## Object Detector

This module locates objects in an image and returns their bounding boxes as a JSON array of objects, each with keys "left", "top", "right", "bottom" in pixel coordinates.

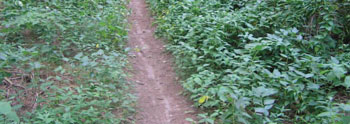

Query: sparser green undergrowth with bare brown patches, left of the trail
[{"left": 0, "top": 0, "right": 134, "bottom": 124}]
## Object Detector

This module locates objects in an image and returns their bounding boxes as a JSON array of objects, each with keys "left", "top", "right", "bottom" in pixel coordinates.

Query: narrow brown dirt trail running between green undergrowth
[{"left": 128, "top": 0, "right": 195, "bottom": 124}]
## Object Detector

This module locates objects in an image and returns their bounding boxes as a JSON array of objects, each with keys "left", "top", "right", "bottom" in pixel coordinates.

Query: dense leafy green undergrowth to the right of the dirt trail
[{"left": 148, "top": 0, "right": 350, "bottom": 124}]
